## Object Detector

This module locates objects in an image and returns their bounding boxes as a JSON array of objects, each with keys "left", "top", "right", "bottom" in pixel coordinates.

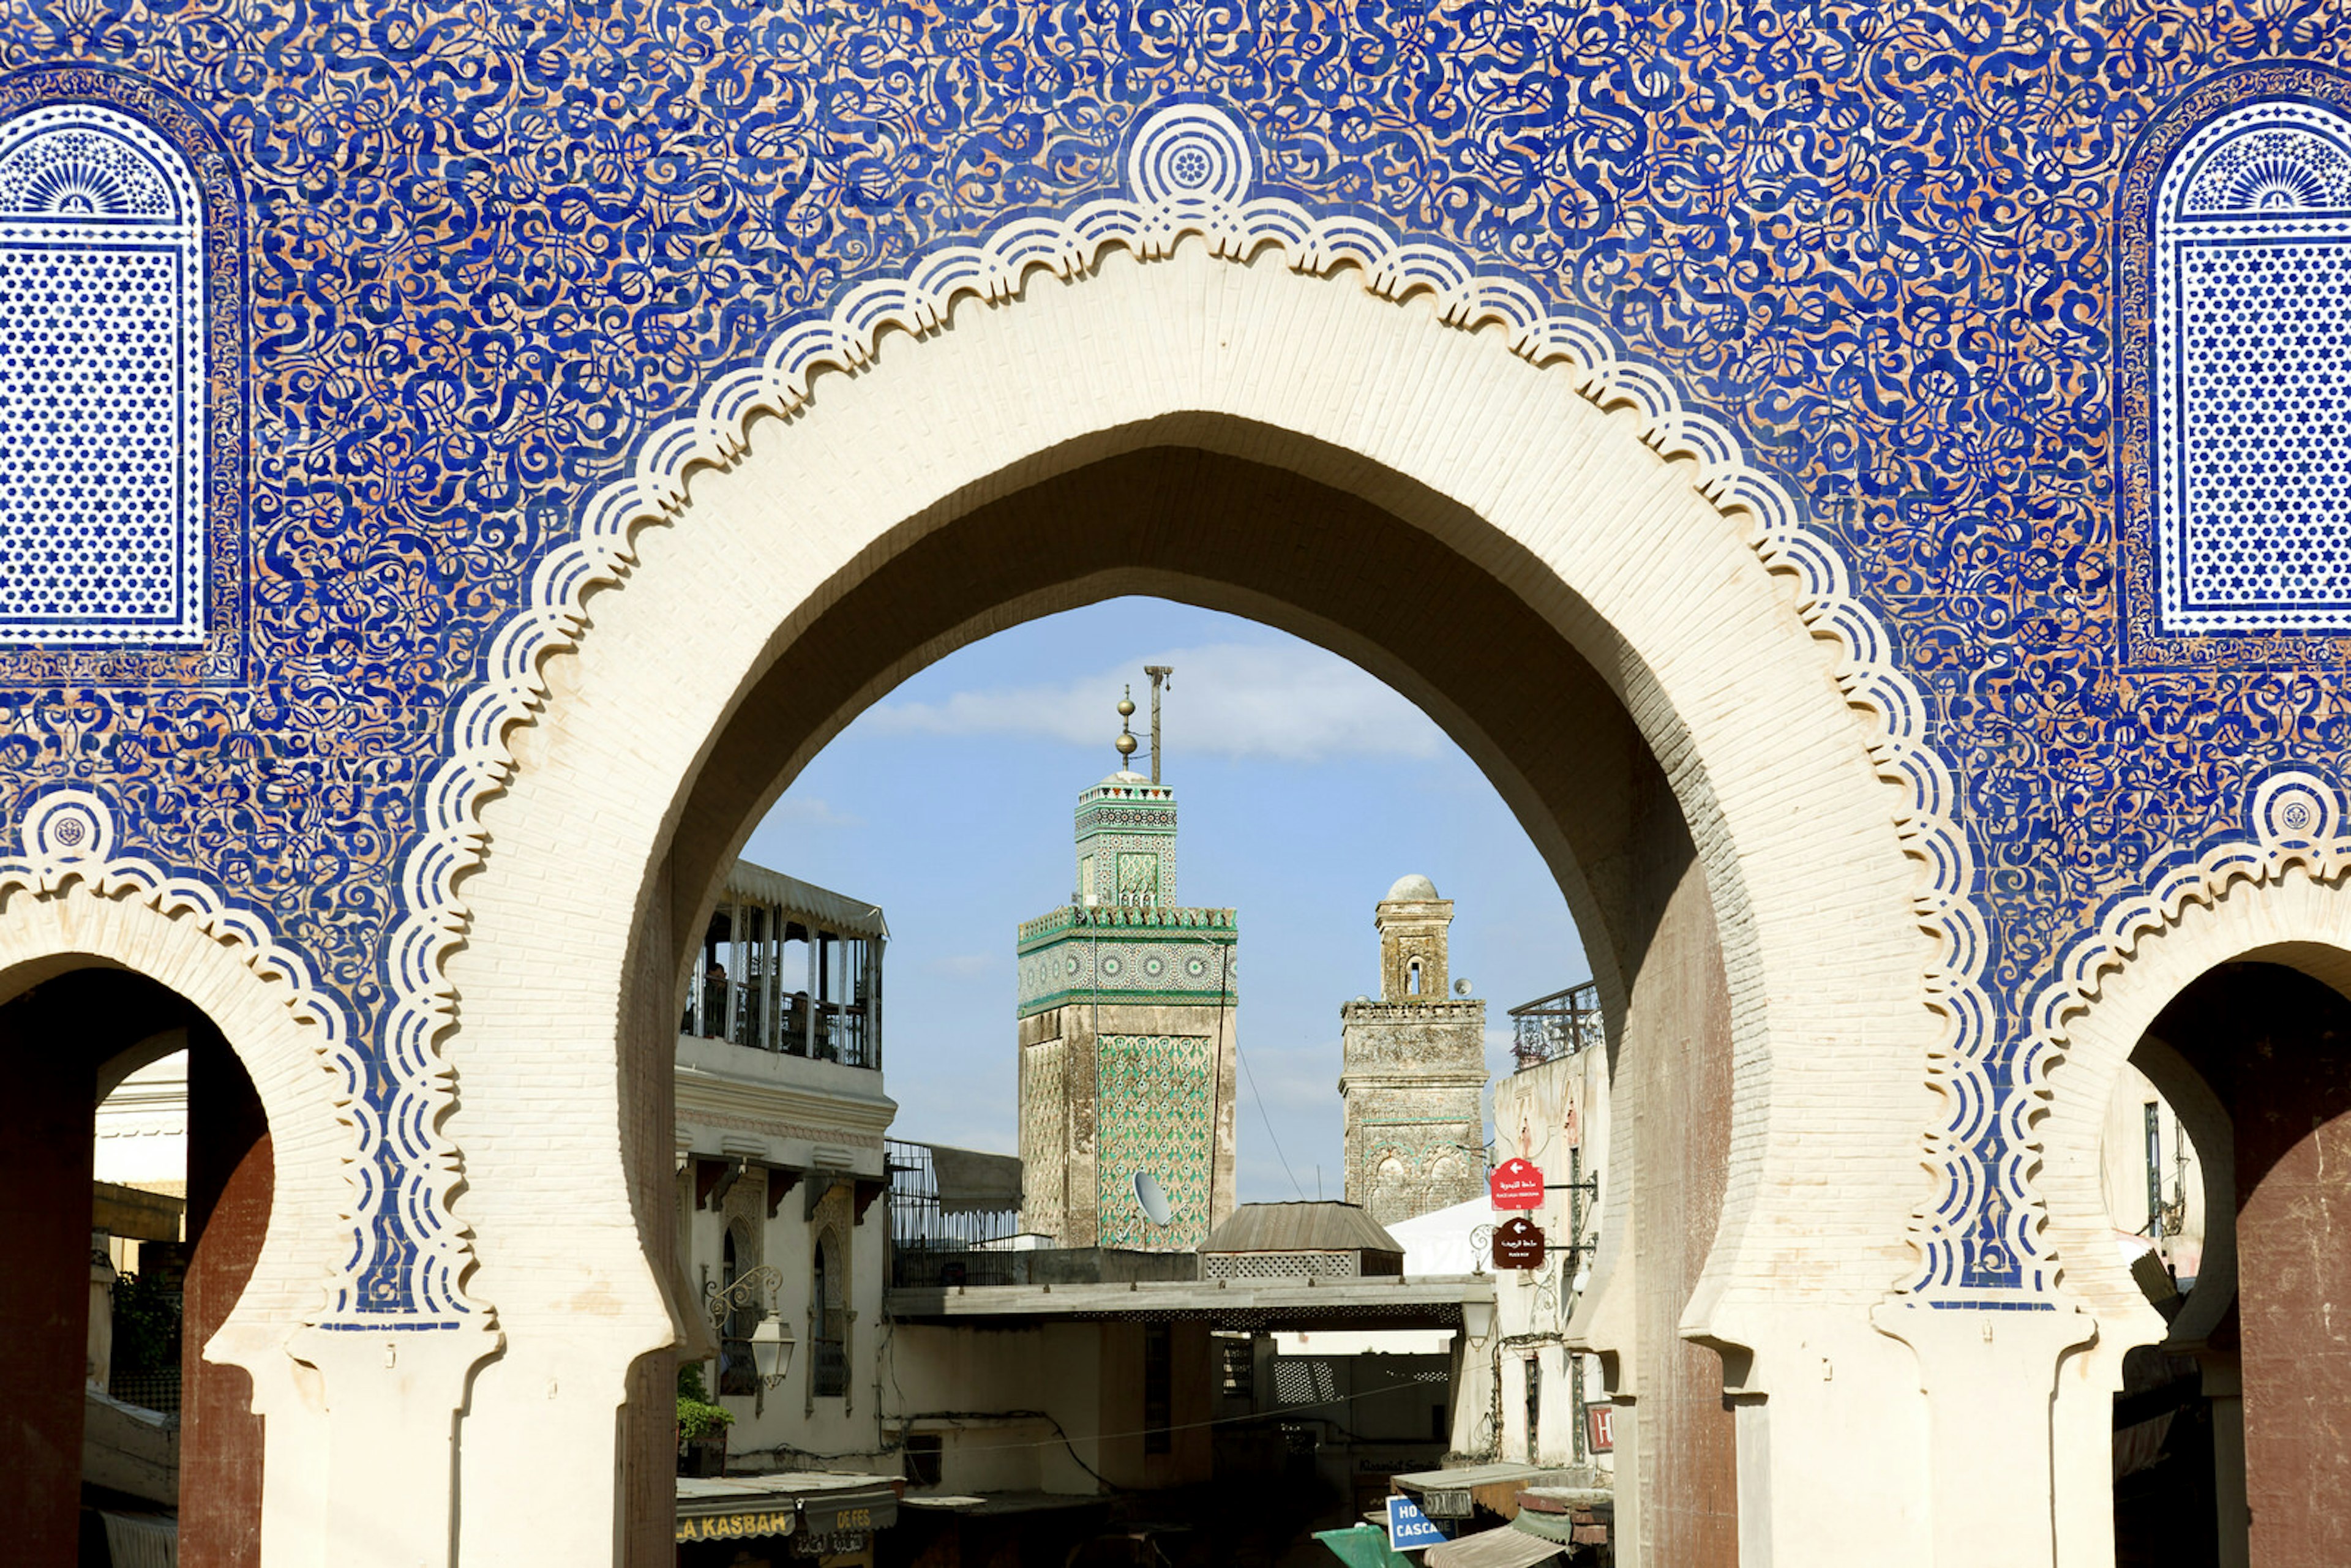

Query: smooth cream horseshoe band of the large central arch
[{"left": 427, "top": 217, "right": 1942, "bottom": 1545}]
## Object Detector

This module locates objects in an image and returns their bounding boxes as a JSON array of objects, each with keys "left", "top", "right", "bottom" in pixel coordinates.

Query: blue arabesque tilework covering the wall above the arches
[{"left": 0, "top": 0, "right": 2351, "bottom": 1314}]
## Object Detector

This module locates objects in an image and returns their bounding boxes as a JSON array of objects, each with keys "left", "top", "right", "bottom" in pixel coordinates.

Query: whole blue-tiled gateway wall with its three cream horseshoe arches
[{"left": 0, "top": 0, "right": 2351, "bottom": 1568}]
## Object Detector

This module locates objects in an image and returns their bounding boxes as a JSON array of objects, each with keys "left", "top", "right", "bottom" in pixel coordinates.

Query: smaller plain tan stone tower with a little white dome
[{"left": 1338, "top": 877, "right": 1486, "bottom": 1225}]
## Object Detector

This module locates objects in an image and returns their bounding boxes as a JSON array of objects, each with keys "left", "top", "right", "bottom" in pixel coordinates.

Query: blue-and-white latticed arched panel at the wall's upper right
[{"left": 2149, "top": 99, "right": 2351, "bottom": 637}]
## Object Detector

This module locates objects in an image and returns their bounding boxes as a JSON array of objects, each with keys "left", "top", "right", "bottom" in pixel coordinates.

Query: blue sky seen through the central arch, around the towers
[{"left": 745, "top": 599, "right": 1587, "bottom": 1201}]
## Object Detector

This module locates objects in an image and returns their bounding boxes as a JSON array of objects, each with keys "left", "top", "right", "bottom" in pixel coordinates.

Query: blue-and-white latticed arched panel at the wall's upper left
[{"left": 0, "top": 103, "right": 212, "bottom": 649}]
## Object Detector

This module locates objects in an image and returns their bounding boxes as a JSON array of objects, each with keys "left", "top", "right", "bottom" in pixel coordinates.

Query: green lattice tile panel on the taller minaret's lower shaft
[{"left": 1093, "top": 1034, "right": 1218, "bottom": 1248}]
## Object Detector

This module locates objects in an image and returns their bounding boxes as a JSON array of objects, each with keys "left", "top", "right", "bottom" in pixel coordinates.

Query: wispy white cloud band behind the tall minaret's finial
[{"left": 860, "top": 642, "right": 1444, "bottom": 767}]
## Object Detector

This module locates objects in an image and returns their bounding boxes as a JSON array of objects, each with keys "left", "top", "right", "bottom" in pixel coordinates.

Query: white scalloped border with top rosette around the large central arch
[{"left": 386, "top": 103, "right": 2022, "bottom": 1311}]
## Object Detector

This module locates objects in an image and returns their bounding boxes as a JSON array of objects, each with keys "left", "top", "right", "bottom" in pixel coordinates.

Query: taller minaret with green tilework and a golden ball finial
[{"left": 1021, "top": 700, "right": 1239, "bottom": 1251}]
